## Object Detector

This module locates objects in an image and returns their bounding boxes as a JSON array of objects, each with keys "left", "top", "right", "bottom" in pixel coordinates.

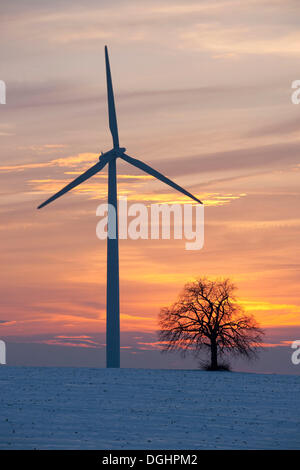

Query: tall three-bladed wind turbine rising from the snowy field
[{"left": 38, "top": 46, "right": 202, "bottom": 367}]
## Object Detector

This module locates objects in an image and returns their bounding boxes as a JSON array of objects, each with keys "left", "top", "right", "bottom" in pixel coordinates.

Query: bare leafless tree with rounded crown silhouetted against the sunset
[{"left": 159, "top": 278, "right": 264, "bottom": 370}]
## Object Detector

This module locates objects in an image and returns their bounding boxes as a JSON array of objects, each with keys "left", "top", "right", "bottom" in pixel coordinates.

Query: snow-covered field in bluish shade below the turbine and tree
[{"left": 0, "top": 366, "right": 300, "bottom": 449}]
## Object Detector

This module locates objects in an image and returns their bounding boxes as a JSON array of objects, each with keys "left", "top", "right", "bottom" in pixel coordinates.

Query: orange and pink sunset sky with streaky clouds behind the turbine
[{"left": 0, "top": 0, "right": 300, "bottom": 373}]
